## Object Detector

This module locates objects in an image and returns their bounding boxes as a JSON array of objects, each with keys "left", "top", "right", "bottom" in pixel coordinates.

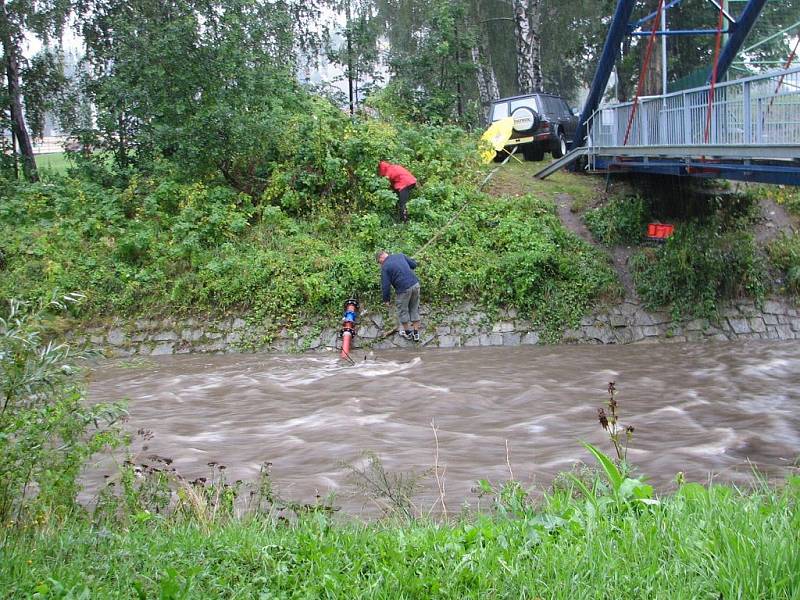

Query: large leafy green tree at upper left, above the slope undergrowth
[{"left": 75, "top": 0, "right": 319, "bottom": 185}]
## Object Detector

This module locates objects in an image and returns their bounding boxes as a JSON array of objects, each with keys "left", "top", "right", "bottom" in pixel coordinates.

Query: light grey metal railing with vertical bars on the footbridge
[{"left": 587, "top": 67, "right": 800, "bottom": 152}]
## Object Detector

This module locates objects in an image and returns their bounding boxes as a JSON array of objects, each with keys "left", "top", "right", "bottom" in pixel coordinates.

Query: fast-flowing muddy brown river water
[{"left": 87, "top": 342, "right": 800, "bottom": 512}]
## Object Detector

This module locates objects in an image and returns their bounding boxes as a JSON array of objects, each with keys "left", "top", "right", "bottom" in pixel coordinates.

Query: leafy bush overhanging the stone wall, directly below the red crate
[{"left": 631, "top": 223, "right": 765, "bottom": 317}]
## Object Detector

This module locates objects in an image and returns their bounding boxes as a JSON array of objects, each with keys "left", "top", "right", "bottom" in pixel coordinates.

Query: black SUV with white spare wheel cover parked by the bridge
[{"left": 491, "top": 93, "right": 578, "bottom": 160}]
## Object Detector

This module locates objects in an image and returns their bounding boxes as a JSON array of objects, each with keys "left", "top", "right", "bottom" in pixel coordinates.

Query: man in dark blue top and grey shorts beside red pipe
[{"left": 375, "top": 250, "right": 420, "bottom": 342}]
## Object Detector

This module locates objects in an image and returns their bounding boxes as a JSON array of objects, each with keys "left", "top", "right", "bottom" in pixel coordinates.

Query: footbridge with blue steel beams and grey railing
[{"left": 537, "top": 0, "right": 800, "bottom": 185}]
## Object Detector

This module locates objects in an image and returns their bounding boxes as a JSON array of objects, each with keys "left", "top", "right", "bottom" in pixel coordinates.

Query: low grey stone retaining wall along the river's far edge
[{"left": 69, "top": 300, "right": 800, "bottom": 356}]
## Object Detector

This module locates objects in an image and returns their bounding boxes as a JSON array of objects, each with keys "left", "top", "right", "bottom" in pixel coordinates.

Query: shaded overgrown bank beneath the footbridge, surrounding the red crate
[{"left": 583, "top": 179, "right": 800, "bottom": 318}]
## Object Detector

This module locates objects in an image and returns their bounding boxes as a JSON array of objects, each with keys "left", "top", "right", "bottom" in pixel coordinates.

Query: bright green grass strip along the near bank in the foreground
[{"left": 0, "top": 477, "right": 800, "bottom": 600}]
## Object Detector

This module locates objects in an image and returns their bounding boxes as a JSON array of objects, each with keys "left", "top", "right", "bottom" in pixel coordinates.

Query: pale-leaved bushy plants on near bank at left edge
[{"left": 0, "top": 297, "right": 121, "bottom": 525}]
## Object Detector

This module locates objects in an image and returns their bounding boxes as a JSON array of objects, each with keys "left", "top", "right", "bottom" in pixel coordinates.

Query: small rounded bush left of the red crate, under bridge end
[{"left": 584, "top": 196, "right": 650, "bottom": 245}]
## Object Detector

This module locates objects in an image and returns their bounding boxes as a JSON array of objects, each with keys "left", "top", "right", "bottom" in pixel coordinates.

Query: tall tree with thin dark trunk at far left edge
[{"left": 0, "top": 0, "right": 72, "bottom": 181}]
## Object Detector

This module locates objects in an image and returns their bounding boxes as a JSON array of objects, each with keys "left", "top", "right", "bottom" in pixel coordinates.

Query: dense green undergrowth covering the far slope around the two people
[{"left": 0, "top": 117, "right": 613, "bottom": 338}]
